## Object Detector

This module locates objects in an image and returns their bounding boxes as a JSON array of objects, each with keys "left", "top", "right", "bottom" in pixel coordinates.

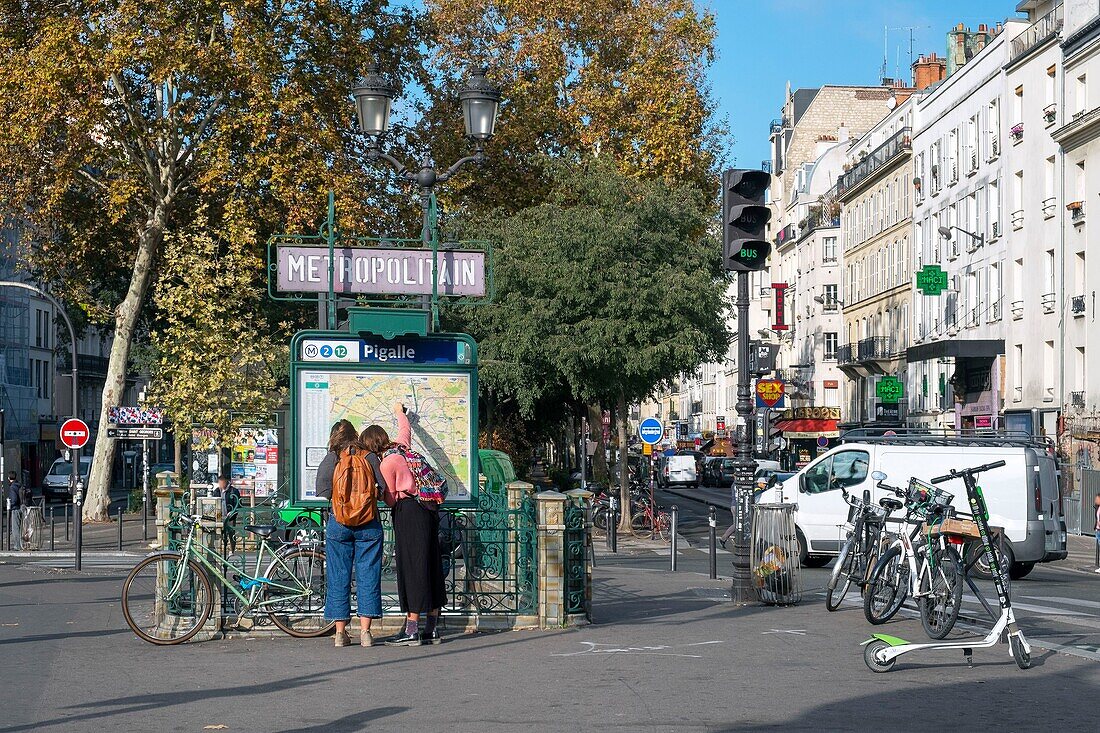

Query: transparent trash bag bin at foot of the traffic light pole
[{"left": 749, "top": 504, "right": 802, "bottom": 605}]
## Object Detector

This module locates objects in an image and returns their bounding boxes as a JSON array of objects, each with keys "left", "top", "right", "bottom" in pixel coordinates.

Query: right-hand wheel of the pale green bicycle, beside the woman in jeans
[{"left": 266, "top": 549, "right": 337, "bottom": 638}]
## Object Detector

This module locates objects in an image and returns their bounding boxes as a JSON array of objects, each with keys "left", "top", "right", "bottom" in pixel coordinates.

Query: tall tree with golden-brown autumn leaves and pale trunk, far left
[{"left": 0, "top": 0, "right": 419, "bottom": 518}]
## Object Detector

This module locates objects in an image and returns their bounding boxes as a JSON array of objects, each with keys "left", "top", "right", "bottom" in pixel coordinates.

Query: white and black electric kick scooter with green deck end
[{"left": 864, "top": 461, "right": 1031, "bottom": 672}]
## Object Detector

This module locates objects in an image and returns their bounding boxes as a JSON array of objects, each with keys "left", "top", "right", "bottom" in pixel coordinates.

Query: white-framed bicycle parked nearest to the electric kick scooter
[{"left": 864, "top": 471, "right": 963, "bottom": 639}]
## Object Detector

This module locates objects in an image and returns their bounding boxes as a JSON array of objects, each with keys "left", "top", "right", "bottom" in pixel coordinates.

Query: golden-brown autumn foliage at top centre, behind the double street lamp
[{"left": 425, "top": 0, "right": 721, "bottom": 210}]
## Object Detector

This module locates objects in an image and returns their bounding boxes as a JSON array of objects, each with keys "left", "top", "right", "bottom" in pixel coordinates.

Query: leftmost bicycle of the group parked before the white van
[{"left": 825, "top": 484, "right": 902, "bottom": 611}]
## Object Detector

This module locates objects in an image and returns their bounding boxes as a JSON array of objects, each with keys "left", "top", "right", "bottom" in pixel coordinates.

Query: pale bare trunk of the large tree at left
[{"left": 84, "top": 220, "right": 166, "bottom": 522}]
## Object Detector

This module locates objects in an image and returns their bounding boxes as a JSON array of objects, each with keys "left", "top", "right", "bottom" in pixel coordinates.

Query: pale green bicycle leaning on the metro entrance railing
[{"left": 122, "top": 514, "right": 336, "bottom": 645}]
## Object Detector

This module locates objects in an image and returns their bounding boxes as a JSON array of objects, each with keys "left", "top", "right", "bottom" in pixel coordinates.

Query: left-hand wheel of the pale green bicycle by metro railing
[{"left": 122, "top": 553, "right": 213, "bottom": 644}]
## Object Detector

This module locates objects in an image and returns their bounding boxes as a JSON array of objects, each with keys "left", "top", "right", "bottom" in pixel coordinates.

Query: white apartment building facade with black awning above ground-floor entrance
[{"left": 906, "top": 20, "right": 1027, "bottom": 429}]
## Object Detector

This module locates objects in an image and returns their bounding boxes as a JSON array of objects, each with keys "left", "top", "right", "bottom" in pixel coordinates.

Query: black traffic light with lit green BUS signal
[{"left": 722, "top": 168, "right": 771, "bottom": 272}]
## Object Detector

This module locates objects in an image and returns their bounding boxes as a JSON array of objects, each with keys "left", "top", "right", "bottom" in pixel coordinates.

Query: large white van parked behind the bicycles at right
[{"left": 757, "top": 435, "right": 1067, "bottom": 578}]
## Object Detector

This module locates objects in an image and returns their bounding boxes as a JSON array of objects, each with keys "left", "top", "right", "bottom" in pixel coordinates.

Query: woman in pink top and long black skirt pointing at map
[{"left": 361, "top": 404, "right": 447, "bottom": 646}]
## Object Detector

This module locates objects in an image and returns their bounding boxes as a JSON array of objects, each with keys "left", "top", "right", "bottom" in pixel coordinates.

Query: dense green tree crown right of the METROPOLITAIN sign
[{"left": 465, "top": 161, "right": 729, "bottom": 484}]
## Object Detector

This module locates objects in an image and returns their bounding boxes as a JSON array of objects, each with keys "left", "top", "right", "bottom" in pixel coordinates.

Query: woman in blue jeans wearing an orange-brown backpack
[{"left": 317, "top": 420, "right": 383, "bottom": 646}]
